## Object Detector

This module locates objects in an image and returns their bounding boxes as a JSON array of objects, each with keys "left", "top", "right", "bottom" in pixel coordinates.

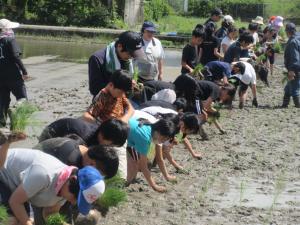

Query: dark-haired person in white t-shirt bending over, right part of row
[{"left": 232, "top": 62, "right": 258, "bottom": 109}]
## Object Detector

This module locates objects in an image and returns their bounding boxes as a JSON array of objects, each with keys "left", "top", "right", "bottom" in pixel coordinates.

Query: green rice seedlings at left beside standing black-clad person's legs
[{"left": 9, "top": 101, "right": 38, "bottom": 131}]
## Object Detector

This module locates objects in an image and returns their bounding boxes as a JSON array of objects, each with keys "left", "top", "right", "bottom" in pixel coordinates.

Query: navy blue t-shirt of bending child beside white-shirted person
[{"left": 205, "top": 61, "right": 231, "bottom": 80}]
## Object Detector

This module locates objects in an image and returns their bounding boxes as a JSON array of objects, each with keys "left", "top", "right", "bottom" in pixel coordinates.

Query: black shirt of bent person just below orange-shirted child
[{"left": 39, "top": 118, "right": 99, "bottom": 145}]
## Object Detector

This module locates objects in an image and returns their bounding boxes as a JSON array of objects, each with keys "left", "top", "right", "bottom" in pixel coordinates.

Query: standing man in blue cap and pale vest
[{"left": 136, "top": 21, "right": 165, "bottom": 82}]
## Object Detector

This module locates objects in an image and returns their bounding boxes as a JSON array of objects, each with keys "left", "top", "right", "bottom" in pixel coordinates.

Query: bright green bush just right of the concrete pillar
[{"left": 144, "top": 0, "right": 174, "bottom": 21}]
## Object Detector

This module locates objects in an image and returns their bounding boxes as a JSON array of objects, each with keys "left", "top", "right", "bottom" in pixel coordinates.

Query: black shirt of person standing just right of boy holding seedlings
[{"left": 200, "top": 36, "right": 219, "bottom": 65}]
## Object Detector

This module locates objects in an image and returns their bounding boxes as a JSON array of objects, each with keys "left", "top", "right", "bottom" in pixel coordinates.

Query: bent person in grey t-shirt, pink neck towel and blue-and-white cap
[{"left": 0, "top": 133, "right": 105, "bottom": 225}]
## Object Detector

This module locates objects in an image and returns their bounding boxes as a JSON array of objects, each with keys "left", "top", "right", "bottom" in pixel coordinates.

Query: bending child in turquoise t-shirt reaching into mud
[{"left": 127, "top": 118, "right": 177, "bottom": 192}]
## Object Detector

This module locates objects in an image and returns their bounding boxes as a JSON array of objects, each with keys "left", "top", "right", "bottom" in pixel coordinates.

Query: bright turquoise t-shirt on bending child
[{"left": 127, "top": 118, "right": 152, "bottom": 156}]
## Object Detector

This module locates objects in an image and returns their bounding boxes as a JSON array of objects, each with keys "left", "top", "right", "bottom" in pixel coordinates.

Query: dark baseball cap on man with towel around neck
[{"left": 118, "top": 31, "right": 145, "bottom": 58}]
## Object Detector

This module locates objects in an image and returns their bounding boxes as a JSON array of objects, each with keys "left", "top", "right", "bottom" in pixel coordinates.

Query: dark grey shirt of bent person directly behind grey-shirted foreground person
[{"left": 33, "top": 137, "right": 83, "bottom": 168}]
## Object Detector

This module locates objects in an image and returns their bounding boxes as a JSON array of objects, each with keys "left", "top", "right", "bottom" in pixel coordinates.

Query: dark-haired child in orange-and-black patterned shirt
[{"left": 83, "top": 70, "right": 133, "bottom": 123}]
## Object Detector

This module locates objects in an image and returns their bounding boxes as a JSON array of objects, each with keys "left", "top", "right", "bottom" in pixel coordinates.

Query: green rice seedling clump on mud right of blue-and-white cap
[{"left": 97, "top": 188, "right": 127, "bottom": 209}]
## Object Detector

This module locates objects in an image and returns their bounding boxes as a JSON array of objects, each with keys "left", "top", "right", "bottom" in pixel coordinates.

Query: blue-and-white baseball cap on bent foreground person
[{"left": 77, "top": 166, "right": 105, "bottom": 215}]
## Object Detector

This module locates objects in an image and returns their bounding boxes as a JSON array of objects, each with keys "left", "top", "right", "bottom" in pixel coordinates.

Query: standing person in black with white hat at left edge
[{"left": 0, "top": 19, "right": 28, "bottom": 127}]
